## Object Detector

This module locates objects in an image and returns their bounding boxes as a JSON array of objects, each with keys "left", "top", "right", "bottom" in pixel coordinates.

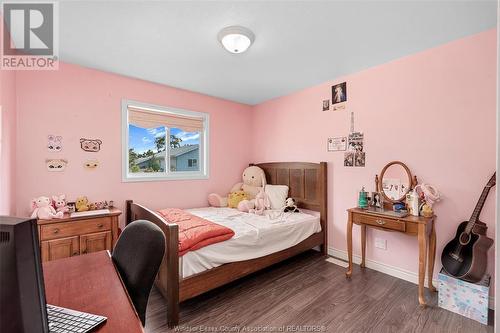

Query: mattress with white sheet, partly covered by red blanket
[{"left": 179, "top": 207, "right": 321, "bottom": 278}]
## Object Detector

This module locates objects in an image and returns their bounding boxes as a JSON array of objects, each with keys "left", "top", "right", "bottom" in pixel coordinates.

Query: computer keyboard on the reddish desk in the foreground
[{"left": 47, "top": 304, "right": 107, "bottom": 333}]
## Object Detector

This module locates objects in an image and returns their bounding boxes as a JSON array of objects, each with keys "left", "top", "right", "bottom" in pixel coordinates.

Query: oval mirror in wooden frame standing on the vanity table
[{"left": 379, "top": 161, "right": 412, "bottom": 203}]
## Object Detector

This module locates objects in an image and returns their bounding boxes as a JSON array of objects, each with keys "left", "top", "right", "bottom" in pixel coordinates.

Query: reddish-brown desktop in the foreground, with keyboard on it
[{"left": 43, "top": 251, "right": 144, "bottom": 333}]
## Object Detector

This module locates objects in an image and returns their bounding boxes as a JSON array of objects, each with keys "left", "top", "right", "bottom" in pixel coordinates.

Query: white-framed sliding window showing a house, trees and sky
[{"left": 126, "top": 100, "right": 207, "bottom": 179}]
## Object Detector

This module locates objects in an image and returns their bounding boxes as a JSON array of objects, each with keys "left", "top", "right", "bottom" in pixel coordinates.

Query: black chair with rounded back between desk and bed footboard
[{"left": 111, "top": 220, "right": 165, "bottom": 326}]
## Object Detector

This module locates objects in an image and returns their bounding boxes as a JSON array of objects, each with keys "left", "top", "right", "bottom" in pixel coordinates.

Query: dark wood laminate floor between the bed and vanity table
[{"left": 146, "top": 251, "right": 493, "bottom": 333}]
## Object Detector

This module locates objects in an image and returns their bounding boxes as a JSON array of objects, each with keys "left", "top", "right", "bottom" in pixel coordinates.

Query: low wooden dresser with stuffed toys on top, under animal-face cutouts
[{"left": 38, "top": 208, "right": 122, "bottom": 262}]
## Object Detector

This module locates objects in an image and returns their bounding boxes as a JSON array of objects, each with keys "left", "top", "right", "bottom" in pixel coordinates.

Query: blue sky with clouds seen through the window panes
[{"left": 128, "top": 124, "right": 200, "bottom": 154}]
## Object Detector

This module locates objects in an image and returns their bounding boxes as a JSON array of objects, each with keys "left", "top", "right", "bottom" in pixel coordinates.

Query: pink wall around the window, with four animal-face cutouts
[{"left": 16, "top": 64, "right": 251, "bottom": 222}]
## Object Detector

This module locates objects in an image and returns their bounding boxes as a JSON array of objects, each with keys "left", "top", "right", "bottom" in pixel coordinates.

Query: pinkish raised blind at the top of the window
[{"left": 128, "top": 107, "right": 203, "bottom": 132}]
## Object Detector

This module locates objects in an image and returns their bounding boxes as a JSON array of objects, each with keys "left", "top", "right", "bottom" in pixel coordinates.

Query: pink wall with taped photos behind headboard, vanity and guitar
[{"left": 253, "top": 30, "right": 496, "bottom": 282}]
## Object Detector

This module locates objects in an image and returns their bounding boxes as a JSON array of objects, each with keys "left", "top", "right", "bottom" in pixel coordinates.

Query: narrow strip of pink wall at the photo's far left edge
[{"left": 0, "top": 67, "right": 16, "bottom": 215}]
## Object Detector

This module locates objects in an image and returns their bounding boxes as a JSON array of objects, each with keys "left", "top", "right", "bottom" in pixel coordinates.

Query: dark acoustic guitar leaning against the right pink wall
[{"left": 441, "top": 172, "right": 496, "bottom": 282}]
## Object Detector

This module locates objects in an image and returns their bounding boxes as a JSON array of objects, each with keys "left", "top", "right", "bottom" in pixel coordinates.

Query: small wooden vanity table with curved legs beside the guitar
[{"left": 346, "top": 208, "right": 436, "bottom": 306}]
